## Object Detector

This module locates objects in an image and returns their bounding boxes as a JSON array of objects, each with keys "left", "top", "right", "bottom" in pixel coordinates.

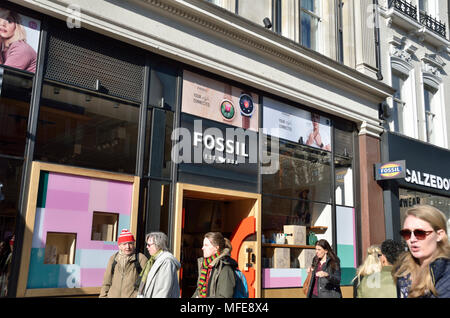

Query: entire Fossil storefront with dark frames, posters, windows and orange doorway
[{"left": 0, "top": 1, "right": 368, "bottom": 297}]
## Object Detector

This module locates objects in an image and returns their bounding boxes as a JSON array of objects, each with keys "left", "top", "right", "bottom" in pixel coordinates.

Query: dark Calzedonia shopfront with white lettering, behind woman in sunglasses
[{"left": 381, "top": 133, "right": 450, "bottom": 240}]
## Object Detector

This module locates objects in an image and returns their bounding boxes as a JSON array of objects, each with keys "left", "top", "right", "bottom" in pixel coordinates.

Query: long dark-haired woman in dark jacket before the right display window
[{"left": 307, "top": 239, "right": 342, "bottom": 298}]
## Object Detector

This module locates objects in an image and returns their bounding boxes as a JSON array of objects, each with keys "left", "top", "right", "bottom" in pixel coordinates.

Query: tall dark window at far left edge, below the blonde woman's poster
[{"left": 0, "top": 67, "right": 33, "bottom": 297}]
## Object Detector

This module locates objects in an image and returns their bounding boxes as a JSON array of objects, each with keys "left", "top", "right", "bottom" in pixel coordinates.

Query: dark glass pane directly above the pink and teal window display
[{"left": 35, "top": 82, "right": 139, "bottom": 174}]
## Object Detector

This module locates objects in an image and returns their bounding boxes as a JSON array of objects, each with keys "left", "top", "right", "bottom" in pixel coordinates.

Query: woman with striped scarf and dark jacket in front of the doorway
[{"left": 192, "top": 232, "right": 238, "bottom": 298}]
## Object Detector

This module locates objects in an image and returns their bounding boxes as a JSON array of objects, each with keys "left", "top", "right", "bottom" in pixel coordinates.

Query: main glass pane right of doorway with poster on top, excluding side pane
[{"left": 262, "top": 97, "right": 334, "bottom": 289}]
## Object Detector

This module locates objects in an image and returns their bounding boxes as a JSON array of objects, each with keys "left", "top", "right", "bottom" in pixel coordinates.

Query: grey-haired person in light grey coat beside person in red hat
[{"left": 137, "top": 232, "right": 181, "bottom": 298}]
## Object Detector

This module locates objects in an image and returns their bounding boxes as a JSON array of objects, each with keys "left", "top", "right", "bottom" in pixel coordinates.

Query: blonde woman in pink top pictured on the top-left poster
[{"left": 0, "top": 8, "right": 37, "bottom": 73}]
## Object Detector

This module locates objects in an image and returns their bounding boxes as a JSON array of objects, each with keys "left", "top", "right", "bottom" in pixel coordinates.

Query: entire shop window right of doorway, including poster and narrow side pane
[{"left": 262, "top": 97, "right": 357, "bottom": 289}]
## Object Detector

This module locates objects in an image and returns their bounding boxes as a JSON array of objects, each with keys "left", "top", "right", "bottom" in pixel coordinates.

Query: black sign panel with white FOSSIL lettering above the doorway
[{"left": 177, "top": 113, "right": 258, "bottom": 193}]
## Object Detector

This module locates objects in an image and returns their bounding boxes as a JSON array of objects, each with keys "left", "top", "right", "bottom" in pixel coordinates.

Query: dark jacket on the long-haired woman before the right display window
[{"left": 307, "top": 256, "right": 342, "bottom": 298}]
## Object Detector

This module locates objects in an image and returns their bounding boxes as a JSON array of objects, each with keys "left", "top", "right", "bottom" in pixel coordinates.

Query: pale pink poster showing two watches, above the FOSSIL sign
[{"left": 181, "top": 71, "right": 259, "bottom": 131}]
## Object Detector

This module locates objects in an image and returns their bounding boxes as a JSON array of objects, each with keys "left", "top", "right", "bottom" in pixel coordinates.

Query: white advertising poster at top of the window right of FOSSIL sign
[{"left": 263, "top": 97, "right": 331, "bottom": 151}]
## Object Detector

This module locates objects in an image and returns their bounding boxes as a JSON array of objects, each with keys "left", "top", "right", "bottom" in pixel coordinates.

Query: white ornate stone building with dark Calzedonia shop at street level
[{"left": 379, "top": 0, "right": 450, "bottom": 239}]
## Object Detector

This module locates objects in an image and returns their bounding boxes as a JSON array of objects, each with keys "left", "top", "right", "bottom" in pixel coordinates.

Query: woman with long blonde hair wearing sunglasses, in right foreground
[{"left": 392, "top": 205, "right": 450, "bottom": 298}]
